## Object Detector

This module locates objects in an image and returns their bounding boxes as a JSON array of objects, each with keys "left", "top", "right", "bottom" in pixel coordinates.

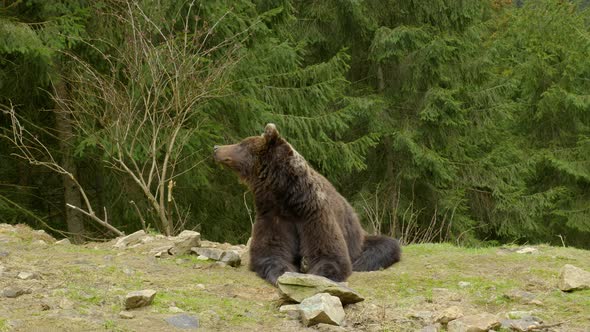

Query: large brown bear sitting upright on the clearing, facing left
[{"left": 214, "top": 123, "right": 401, "bottom": 284}]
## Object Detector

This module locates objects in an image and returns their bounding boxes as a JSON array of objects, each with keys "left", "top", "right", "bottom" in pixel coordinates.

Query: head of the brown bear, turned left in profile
[{"left": 213, "top": 123, "right": 295, "bottom": 185}]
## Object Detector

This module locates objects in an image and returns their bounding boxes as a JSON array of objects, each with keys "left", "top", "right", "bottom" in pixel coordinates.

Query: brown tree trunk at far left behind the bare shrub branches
[{"left": 54, "top": 75, "right": 84, "bottom": 243}]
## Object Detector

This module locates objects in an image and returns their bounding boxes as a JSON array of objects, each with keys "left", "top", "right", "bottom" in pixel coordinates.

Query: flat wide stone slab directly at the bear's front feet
[{"left": 277, "top": 272, "right": 364, "bottom": 304}]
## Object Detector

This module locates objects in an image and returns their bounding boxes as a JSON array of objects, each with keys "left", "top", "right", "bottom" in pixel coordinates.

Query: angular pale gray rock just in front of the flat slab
[{"left": 299, "top": 293, "right": 345, "bottom": 326}]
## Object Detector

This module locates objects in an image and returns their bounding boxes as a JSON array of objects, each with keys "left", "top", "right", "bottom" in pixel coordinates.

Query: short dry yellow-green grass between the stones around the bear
[{"left": 0, "top": 224, "right": 590, "bottom": 331}]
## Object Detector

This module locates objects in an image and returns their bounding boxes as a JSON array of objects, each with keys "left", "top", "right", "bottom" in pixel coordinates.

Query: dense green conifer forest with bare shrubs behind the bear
[{"left": 0, "top": 0, "right": 590, "bottom": 248}]
